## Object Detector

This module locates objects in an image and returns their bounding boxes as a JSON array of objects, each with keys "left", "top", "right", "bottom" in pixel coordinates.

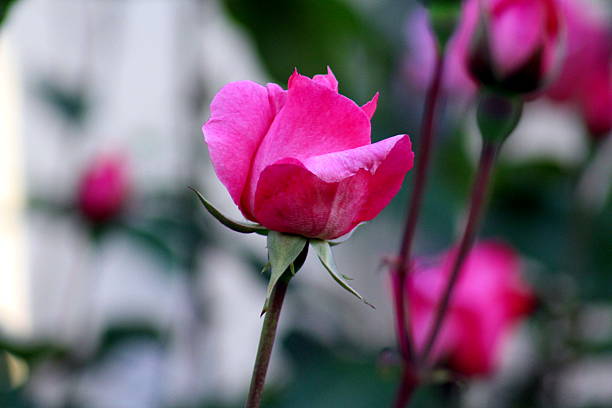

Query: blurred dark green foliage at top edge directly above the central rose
[{"left": 218, "top": 0, "right": 400, "bottom": 102}]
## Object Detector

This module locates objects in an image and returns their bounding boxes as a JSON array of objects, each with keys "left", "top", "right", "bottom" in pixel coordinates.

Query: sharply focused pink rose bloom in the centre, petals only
[{"left": 202, "top": 69, "right": 413, "bottom": 239}]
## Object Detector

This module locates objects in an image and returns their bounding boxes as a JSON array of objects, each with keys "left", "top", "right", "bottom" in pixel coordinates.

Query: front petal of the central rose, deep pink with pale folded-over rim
[{"left": 254, "top": 135, "right": 413, "bottom": 239}]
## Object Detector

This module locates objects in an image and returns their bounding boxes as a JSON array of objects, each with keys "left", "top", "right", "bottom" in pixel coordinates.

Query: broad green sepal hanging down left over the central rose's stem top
[{"left": 261, "top": 231, "right": 308, "bottom": 315}]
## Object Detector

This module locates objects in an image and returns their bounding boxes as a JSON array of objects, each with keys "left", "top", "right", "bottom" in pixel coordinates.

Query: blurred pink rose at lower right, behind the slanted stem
[{"left": 407, "top": 241, "right": 535, "bottom": 376}]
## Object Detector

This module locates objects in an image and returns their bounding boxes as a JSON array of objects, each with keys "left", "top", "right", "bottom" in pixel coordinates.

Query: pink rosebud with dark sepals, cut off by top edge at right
[{"left": 466, "top": 0, "right": 561, "bottom": 94}]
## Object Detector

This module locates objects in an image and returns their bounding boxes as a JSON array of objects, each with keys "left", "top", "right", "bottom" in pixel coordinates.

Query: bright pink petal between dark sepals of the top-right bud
[{"left": 489, "top": 0, "right": 546, "bottom": 76}]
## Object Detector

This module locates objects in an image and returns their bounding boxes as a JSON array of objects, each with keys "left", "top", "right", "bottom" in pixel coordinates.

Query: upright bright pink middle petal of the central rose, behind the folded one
[{"left": 246, "top": 73, "right": 370, "bottom": 214}]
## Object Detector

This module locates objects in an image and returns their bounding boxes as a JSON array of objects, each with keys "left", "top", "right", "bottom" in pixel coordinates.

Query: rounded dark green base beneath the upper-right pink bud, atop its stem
[{"left": 476, "top": 92, "right": 523, "bottom": 143}]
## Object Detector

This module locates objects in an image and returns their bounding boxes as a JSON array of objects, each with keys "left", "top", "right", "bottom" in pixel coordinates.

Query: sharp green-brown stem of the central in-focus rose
[{"left": 245, "top": 273, "right": 291, "bottom": 408}]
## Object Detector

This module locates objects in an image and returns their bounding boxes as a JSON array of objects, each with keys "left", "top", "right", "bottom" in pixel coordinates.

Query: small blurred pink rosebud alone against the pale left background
[{"left": 78, "top": 155, "right": 129, "bottom": 223}]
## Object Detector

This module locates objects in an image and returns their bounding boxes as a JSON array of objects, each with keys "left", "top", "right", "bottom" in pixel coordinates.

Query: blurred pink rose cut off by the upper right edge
[{"left": 547, "top": 0, "right": 612, "bottom": 136}]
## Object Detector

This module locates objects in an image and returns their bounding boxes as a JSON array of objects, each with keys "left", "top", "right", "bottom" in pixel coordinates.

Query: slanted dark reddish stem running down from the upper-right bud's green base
[{"left": 419, "top": 141, "right": 501, "bottom": 365}]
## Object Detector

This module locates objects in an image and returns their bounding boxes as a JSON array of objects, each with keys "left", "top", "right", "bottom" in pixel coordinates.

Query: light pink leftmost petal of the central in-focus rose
[{"left": 202, "top": 81, "right": 282, "bottom": 212}]
